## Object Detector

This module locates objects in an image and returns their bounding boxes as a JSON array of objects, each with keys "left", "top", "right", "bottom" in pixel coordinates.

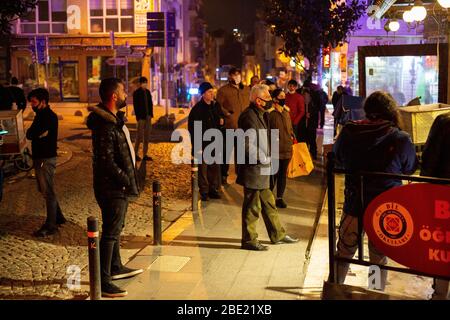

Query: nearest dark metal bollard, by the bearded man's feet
[{"left": 87, "top": 217, "right": 102, "bottom": 300}]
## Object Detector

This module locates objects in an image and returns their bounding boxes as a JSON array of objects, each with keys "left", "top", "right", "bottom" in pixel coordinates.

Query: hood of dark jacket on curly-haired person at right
[{"left": 341, "top": 120, "right": 399, "bottom": 150}]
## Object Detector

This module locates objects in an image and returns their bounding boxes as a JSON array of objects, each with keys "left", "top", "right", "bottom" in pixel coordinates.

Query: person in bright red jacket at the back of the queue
[{"left": 286, "top": 79, "right": 306, "bottom": 142}]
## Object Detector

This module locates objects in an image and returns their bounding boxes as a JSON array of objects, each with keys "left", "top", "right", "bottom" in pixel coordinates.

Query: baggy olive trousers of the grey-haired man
[{"left": 242, "top": 188, "right": 286, "bottom": 245}]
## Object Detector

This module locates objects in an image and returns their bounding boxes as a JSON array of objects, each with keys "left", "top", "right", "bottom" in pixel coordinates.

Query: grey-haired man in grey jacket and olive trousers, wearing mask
[{"left": 236, "top": 85, "right": 298, "bottom": 251}]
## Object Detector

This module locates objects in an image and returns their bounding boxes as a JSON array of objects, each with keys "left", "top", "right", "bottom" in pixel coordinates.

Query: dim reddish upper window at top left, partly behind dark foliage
[{"left": 20, "top": 0, "right": 67, "bottom": 34}]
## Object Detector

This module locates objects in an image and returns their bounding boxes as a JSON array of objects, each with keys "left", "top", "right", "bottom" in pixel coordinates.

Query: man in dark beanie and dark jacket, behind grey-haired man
[{"left": 188, "top": 82, "right": 224, "bottom": 201}]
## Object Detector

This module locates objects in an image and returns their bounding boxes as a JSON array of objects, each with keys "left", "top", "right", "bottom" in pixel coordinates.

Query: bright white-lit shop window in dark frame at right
[{"left": 366, "top": 56, "right": 439, "bottom": 106}]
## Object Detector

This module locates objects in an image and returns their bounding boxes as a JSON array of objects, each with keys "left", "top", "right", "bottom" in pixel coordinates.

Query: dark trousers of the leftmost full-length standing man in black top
[{"left": 33, "top": 157, "right": 64, "bottom": 228}]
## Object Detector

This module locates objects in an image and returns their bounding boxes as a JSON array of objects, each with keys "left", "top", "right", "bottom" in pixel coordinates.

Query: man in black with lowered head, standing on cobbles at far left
[{"left": 26, "top": 88, "right": 66, "bottom": 237}]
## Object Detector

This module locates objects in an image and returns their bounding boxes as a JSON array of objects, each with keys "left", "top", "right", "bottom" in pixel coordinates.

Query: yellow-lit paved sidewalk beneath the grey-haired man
[{"left": 107, "top": 162, "right": 324, "bottom": 300}]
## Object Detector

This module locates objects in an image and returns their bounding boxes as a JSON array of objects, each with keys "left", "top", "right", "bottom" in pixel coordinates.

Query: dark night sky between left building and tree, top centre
[{"left": 202, "top": 0, "right": 260, "bottom": 33}]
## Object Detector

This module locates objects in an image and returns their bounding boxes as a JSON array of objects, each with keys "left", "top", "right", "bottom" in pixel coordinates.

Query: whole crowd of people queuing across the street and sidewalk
[{"left": 0, "top": 63, "right": 450, "bottom": 298}]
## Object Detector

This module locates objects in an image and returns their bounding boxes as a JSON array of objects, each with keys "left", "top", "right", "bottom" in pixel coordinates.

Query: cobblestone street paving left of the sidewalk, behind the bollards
[{"left": 0, "top": 131, "right": 191, "bottom": 299}]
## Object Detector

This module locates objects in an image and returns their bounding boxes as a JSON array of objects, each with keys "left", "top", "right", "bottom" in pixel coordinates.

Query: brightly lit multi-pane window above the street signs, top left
[{"left": 89, "top": 0, "right": 134, "bottom": 33}]
